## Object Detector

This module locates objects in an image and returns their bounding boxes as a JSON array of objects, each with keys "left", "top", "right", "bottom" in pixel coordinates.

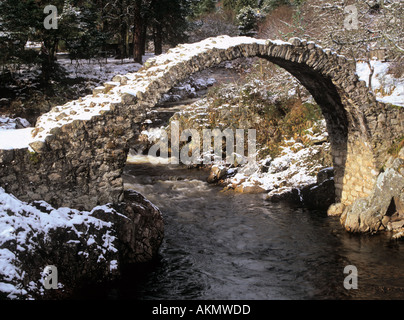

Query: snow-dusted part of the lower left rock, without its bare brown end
[{"left": 0, "top": 188, "right": 118, "bottom": 299}]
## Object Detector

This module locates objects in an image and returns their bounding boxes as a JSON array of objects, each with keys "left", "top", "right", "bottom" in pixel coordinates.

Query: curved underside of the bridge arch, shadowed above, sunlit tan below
[{"left": 264, "top": 57, "right": 377, "bottom": 205}]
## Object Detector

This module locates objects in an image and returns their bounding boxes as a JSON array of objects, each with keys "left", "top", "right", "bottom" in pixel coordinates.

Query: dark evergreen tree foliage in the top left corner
[{"left": 0, "top": 0, "right": 102, "bottom": 84}]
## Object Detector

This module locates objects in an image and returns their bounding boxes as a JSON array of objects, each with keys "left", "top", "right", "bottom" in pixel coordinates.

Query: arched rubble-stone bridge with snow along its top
[{"left": 0, "top": 36, "right": 404, "bottom": 229}]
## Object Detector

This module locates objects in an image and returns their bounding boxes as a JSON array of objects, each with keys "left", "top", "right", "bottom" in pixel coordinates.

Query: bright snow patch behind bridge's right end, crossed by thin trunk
[{"left": 356, "top": 60, "right": 404, "bottom": 107}]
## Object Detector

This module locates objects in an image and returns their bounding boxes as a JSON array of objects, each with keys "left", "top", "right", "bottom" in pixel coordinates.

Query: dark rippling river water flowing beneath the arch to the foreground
[{"left": 98, "top": 164, "right": 404, "bottom": 300}]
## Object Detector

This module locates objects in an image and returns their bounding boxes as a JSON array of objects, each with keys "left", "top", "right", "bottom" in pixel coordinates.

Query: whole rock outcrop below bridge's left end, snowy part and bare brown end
[{"left": 0, "top": 188, "right": 164, "bottom": 299}]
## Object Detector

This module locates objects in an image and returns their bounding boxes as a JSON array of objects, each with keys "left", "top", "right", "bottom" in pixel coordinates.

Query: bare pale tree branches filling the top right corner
[{"left": 296, "top": 0, "right": 404, "bottom": 60}]
